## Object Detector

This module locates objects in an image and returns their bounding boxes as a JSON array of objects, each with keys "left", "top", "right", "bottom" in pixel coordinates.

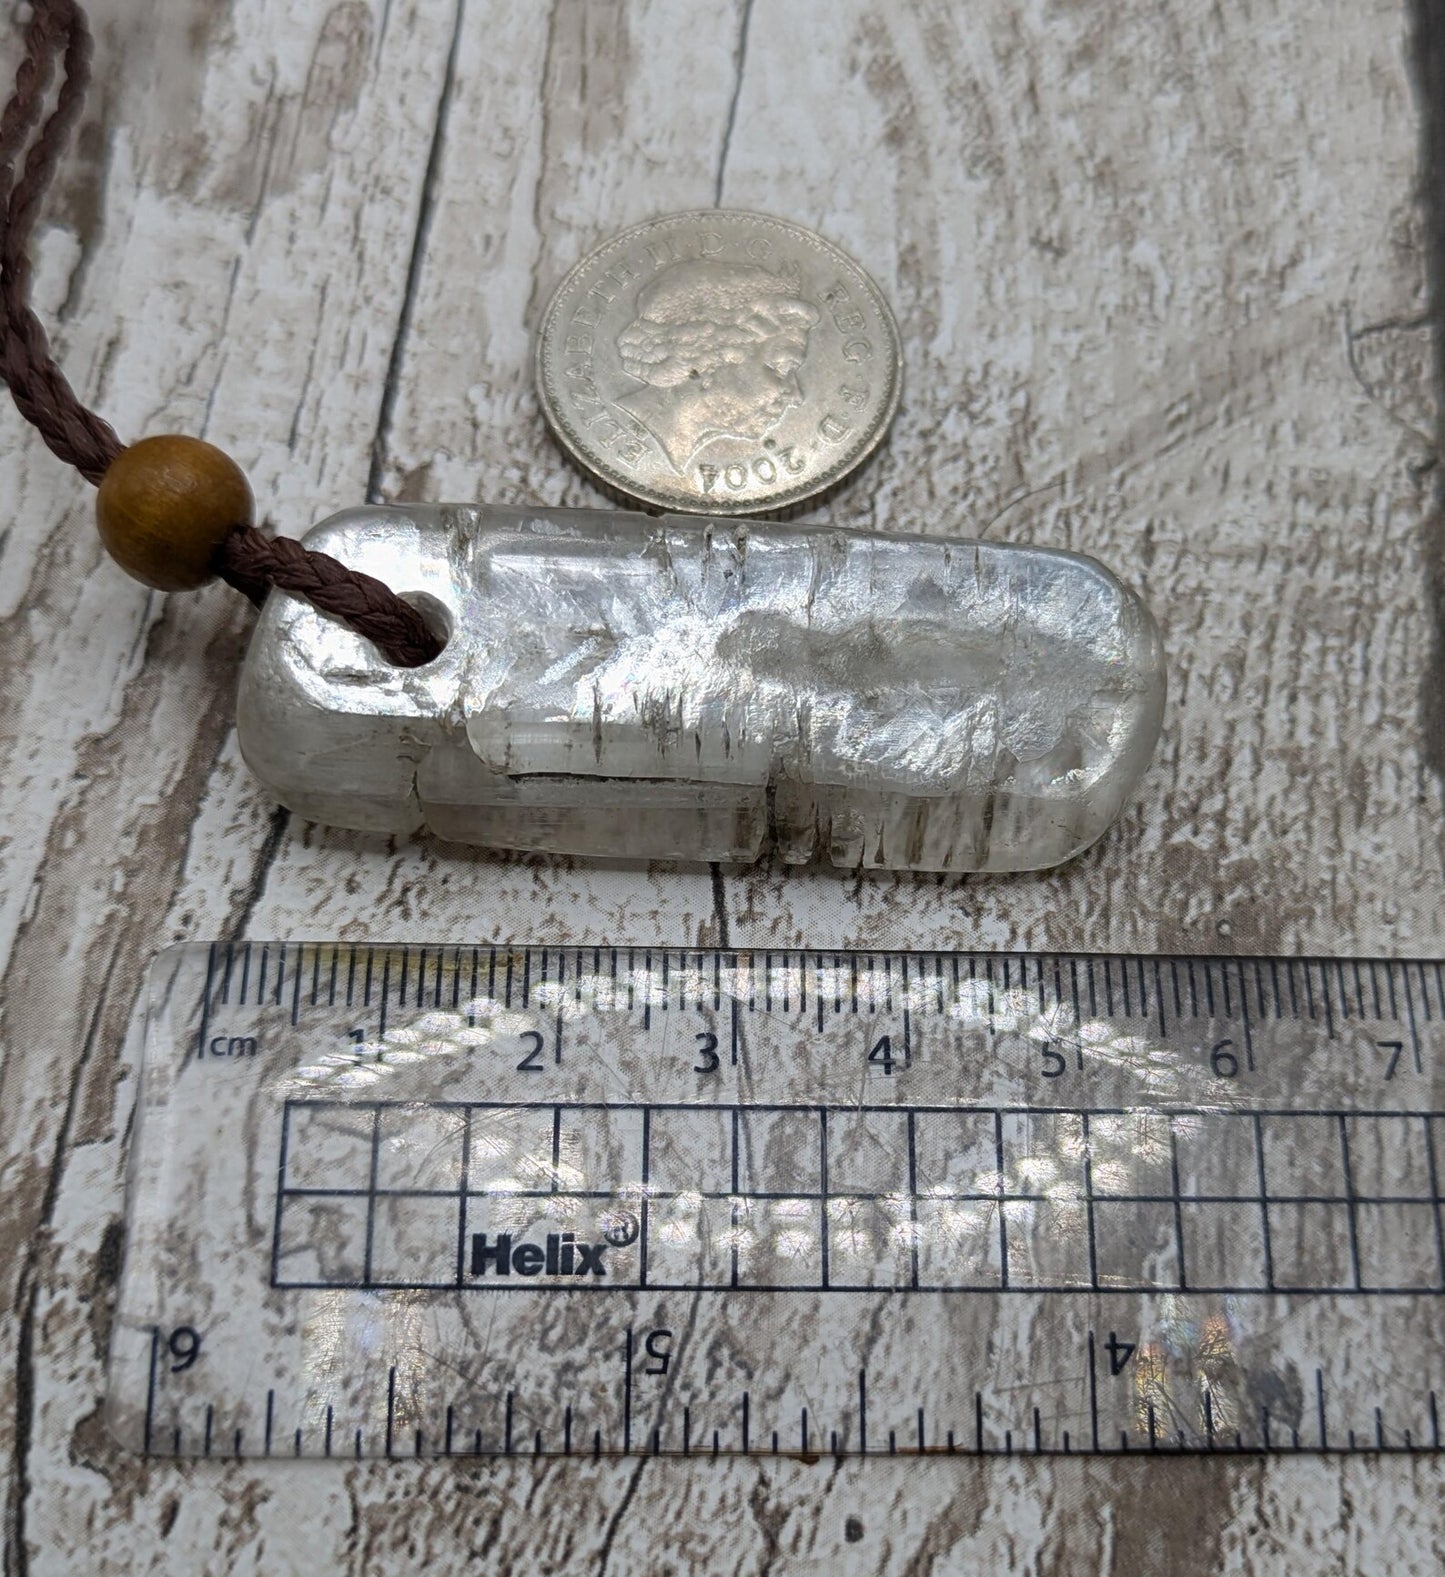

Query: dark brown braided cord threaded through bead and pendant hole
[{"left": 0, "top": 0, "right": 442, "bottom": 667}]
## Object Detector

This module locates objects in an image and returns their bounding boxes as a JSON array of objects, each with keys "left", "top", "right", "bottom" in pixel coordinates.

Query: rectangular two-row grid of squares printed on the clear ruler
[{"left": 273, "top": 1101, "right": 1445, "bottom": 1293}]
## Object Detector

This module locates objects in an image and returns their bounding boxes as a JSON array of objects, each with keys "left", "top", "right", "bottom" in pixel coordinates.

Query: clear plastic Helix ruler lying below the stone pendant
[{"left": 110, "top": 943, "right": 1445, "bottom": 1459}]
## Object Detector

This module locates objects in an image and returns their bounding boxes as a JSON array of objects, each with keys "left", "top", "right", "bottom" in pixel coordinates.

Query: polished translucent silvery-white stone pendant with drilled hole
[{"left": 240, "top": 505, "right": 1164, "bottom": 871}]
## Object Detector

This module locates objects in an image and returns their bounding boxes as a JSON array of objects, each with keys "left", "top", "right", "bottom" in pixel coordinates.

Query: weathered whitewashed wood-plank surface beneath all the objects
[{"left": 0, "top": 0, "right": 1445, "bottom": 1574}]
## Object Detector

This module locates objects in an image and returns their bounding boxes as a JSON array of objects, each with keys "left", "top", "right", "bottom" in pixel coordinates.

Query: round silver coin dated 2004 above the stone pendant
[{"left": 536, "top": 208, "right": 902, "bottom": 514}]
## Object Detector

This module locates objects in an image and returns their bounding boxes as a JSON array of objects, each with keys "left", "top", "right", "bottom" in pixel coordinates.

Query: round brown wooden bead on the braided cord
[{"left": 95, "top": 434, "right": 256, "bottom": 591}]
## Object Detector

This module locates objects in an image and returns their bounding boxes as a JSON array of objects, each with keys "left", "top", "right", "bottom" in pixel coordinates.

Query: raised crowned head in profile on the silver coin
[{"left": 615, "top": 259, "right": 820, "bottom": 473}]
